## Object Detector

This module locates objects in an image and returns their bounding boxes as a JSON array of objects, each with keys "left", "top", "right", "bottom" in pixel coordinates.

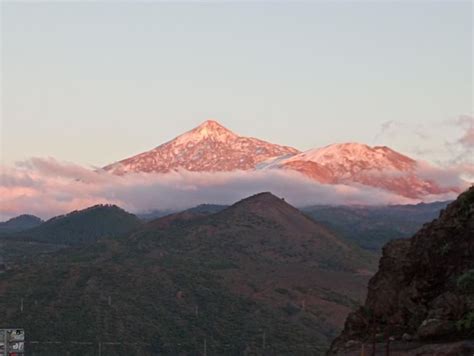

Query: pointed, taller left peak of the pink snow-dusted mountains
[{"left": 104, "top": 120, "right": 299, "bottom": 175}]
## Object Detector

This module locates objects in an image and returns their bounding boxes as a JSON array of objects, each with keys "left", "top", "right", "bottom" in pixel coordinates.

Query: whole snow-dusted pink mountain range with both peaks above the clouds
[{"left": 104, "top": 120, "right": 460, "bottom": 199}]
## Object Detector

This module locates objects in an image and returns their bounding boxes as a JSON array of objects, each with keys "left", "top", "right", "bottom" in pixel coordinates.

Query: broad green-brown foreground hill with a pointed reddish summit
[{"left": 0, "top": 193, "right": 374, "bottom": 355}]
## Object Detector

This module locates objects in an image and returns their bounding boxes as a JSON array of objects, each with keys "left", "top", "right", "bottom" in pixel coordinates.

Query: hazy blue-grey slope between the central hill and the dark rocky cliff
[{"left": 301, "top": 202, "right": 449, "bottom": 252}]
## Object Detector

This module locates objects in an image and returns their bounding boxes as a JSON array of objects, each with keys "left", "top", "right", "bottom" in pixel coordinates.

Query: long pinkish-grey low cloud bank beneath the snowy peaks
[{"left": 0, "top": 158, "right": 466, "bottom": 220}]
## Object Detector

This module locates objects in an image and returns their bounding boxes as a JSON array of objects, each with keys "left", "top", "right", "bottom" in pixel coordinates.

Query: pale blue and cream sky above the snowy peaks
[{"left": 1, "top": 1, "right": 473, "bottom": 165}]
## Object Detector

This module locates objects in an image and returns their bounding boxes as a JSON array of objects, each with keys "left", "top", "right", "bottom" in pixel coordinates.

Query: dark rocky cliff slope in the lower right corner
[{"left": 331, "top": 186, "right": 474, "bottom": 355}]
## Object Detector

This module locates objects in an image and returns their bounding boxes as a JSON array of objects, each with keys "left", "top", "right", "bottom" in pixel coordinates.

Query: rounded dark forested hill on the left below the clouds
[{"left": 15, "top": 205, "right": 141, "bottom": 245}]
